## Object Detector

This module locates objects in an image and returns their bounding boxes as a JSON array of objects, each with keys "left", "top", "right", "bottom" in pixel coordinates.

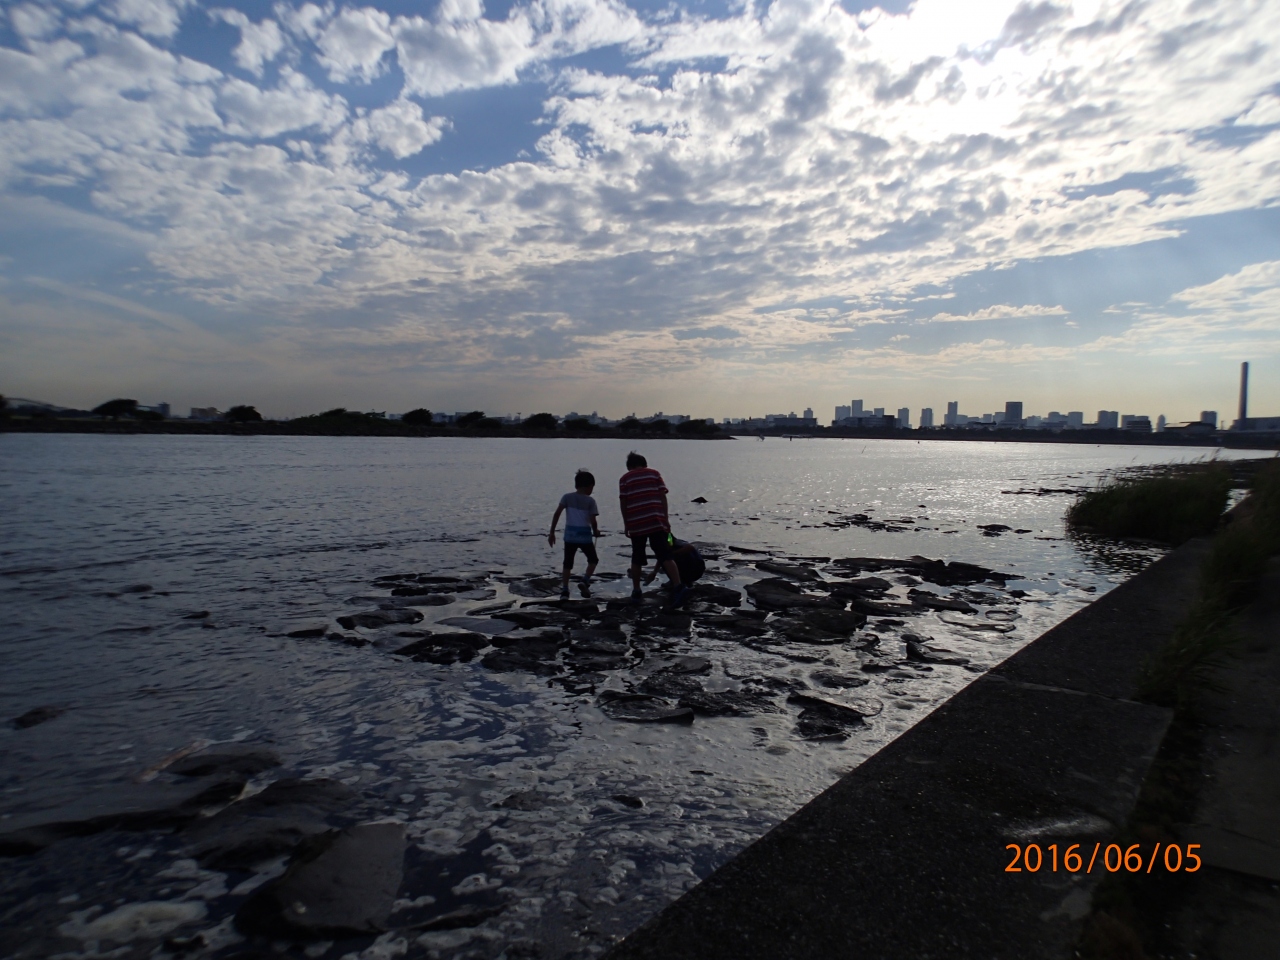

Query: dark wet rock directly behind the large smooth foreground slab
[{"left": 183, "top": 780, "right": 357, "bottom": 870}]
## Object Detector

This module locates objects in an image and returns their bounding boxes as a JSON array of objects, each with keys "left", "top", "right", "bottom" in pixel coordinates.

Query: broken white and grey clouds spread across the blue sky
[{"left": 0, "top": 0, "right": 1280, "bottom": 412}]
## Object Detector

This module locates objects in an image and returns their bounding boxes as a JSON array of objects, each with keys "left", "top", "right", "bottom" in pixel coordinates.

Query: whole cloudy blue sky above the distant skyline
[{"left": 0, "top": 0, "right": 1280, "bottom": 421}]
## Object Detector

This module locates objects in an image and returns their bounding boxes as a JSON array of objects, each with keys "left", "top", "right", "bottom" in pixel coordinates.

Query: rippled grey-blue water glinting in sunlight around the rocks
[{"left": 0, "top": 435, "right": 1247, "bottom": 957}]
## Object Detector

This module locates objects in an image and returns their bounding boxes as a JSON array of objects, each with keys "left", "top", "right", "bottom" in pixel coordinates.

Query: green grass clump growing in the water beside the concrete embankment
[{"left": 1066, "top": 463, "right": 1231, "bottom": 547}]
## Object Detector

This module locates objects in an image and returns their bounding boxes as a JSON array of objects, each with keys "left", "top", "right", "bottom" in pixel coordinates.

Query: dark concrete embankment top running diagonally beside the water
[{"left": 607, "top": 540, "right": 1207, "bottom": 960}]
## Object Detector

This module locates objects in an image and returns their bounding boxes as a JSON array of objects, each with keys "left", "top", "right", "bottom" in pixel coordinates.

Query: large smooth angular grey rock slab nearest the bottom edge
[{"left": 236, "top": 823, "right": 404, "bottom": 940}]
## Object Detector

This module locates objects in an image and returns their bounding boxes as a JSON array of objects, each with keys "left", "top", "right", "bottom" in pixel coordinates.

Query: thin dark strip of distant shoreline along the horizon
[{"left": 0, "top": 417, "right": 1280, "bottom": 451}]
